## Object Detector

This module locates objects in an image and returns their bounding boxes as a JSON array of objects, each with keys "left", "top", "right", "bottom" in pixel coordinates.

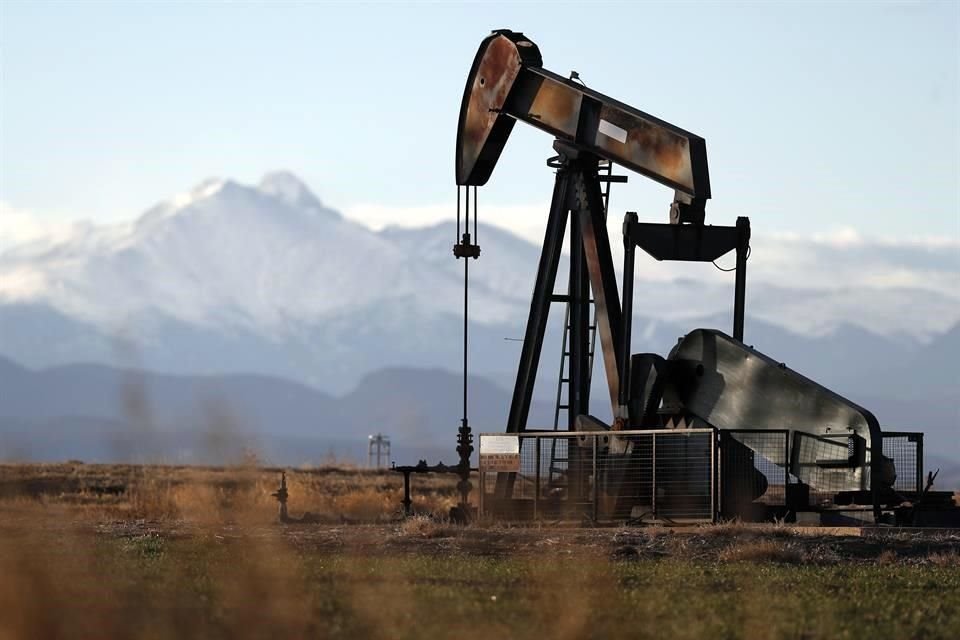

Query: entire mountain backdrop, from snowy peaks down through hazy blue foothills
[{"left": 0, "top": 172, "right": 960, "bottom": 472}]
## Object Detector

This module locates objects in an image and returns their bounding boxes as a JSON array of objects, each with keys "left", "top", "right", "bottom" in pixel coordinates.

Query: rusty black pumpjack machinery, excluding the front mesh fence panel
[{"left": 454, "top": 30, "right": 949, "bottom": 523}]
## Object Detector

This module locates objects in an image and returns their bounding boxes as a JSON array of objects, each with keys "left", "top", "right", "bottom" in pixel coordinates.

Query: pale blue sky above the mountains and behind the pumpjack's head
[{"left": 0, "top": 0, "right": 960, "bottom": 241}]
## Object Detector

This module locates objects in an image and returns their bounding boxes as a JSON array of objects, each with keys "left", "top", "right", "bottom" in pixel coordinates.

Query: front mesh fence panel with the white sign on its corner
[{"left": 480, "top": 429, "right": 718, "bottom": 522}]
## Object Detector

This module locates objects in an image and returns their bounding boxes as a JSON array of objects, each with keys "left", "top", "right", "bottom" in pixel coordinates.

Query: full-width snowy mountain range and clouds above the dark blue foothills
[{"left": 0, "top": 172, "right": 960, "bottom": 392}]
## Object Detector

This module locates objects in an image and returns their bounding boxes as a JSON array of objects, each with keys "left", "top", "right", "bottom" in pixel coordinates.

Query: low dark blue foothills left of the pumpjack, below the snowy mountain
[{"left": 0, "top": 358, "right": 550, "bottom": 465}]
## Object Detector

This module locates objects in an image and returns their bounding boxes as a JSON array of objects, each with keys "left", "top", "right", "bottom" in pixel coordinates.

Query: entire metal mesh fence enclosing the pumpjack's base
[{"left": 480, "top": 429, "right": 923, "bottom": 523}]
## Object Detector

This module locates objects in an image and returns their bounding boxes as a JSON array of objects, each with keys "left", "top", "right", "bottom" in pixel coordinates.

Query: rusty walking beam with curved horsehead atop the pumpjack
[{"left": 456, "top": 30, "right": 710, "bottom": 223}]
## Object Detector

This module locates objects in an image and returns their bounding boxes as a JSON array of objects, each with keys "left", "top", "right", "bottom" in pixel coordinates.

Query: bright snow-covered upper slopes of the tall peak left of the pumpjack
[{"left": 0, "top": 173, "right": 509, "bottom": 332}]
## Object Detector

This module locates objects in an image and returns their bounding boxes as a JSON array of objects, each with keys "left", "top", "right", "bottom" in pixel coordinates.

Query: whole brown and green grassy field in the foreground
[{"left": 0, "top": 463, "right": 960, "bottom": 640}]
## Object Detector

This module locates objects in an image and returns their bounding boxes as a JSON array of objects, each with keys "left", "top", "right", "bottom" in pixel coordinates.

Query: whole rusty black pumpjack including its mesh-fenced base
[{"left": 454, "top": 30, "right": 957, "bottom": 524}]
